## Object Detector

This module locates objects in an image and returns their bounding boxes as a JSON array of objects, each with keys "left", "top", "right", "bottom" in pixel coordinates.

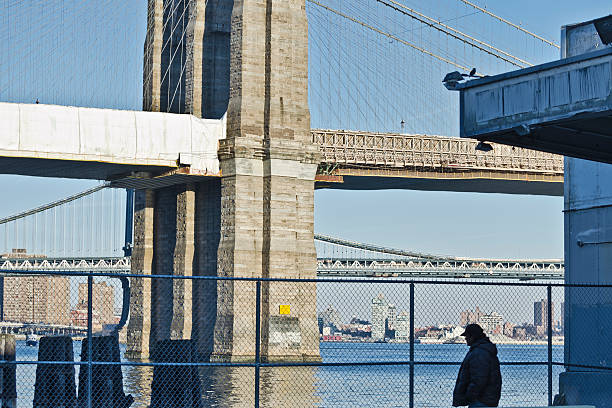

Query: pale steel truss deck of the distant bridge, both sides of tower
[{"left": 0, "top": 257, "right": 564, "bottom": 280}]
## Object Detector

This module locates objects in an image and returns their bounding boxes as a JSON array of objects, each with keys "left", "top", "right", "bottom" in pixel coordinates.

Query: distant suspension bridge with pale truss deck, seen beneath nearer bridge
[{"left": 0, "top": 184, "right": 563, "bottom": 280}]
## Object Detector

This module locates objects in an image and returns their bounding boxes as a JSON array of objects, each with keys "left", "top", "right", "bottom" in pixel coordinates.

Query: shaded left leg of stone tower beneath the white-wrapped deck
[{"left": 126, "top": 185, "right": 195, "bottom": 359}]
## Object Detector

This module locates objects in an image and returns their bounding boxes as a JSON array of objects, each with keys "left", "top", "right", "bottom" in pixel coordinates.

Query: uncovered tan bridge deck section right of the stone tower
[{"left": 312, "top": 130, "right": 563, "bottom": 196}]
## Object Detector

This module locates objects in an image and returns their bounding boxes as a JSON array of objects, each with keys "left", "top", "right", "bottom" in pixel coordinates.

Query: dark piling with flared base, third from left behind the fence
[{"left": 78, "top": 336, "right": 134, "bottom": 408}]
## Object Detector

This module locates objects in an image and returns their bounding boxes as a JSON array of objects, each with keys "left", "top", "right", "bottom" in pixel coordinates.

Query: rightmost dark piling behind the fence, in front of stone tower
[{"left": 150, "top": 340, "right": 202, "bottom": 408}]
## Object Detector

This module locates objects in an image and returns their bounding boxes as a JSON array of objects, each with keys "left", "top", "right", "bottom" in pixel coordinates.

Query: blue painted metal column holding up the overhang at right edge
[{"left": 559, "top": 16, "right": 612, "bottom": 408}]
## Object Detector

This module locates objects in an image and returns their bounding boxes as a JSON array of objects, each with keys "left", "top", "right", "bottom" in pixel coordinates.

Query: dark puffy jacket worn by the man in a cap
[{"left": 453, "top": 337, "right": 501, "bottom": 407}]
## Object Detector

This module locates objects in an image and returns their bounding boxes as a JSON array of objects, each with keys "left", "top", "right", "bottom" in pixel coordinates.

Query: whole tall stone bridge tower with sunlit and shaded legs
[{"left": 127, "top": 0, "right": 319, "bottom": 361}]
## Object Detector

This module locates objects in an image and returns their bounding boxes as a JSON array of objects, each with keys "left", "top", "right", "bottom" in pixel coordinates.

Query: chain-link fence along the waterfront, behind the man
[{"left": 0, "top": 271, "right": 612, "bottom": 408}]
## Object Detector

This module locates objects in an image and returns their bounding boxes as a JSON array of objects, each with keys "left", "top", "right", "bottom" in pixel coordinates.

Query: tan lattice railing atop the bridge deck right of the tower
[{"left": 312, "top": 129, "right": 563, "bottom": 176}]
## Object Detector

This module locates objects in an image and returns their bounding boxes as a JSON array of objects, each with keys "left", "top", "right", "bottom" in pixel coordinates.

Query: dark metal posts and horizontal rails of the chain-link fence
[{"left": 0, "top": 270, "right": 612, "bottom": 408}]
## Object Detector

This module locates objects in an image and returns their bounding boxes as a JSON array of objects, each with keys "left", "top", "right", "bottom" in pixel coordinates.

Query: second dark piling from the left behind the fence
[{"left": 33, "top": 336, "right": 76, "bottom": 408}]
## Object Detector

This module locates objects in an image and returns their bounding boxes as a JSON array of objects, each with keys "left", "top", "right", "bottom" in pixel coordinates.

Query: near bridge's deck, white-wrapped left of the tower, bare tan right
[{"left": 0, "top": 103, "right": 563, "bottom": 196}]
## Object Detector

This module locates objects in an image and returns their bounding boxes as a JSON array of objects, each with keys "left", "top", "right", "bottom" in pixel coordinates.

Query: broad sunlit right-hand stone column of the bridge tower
[{"left": 213, "top": 0, "right": 320, "bottom": 361}]
